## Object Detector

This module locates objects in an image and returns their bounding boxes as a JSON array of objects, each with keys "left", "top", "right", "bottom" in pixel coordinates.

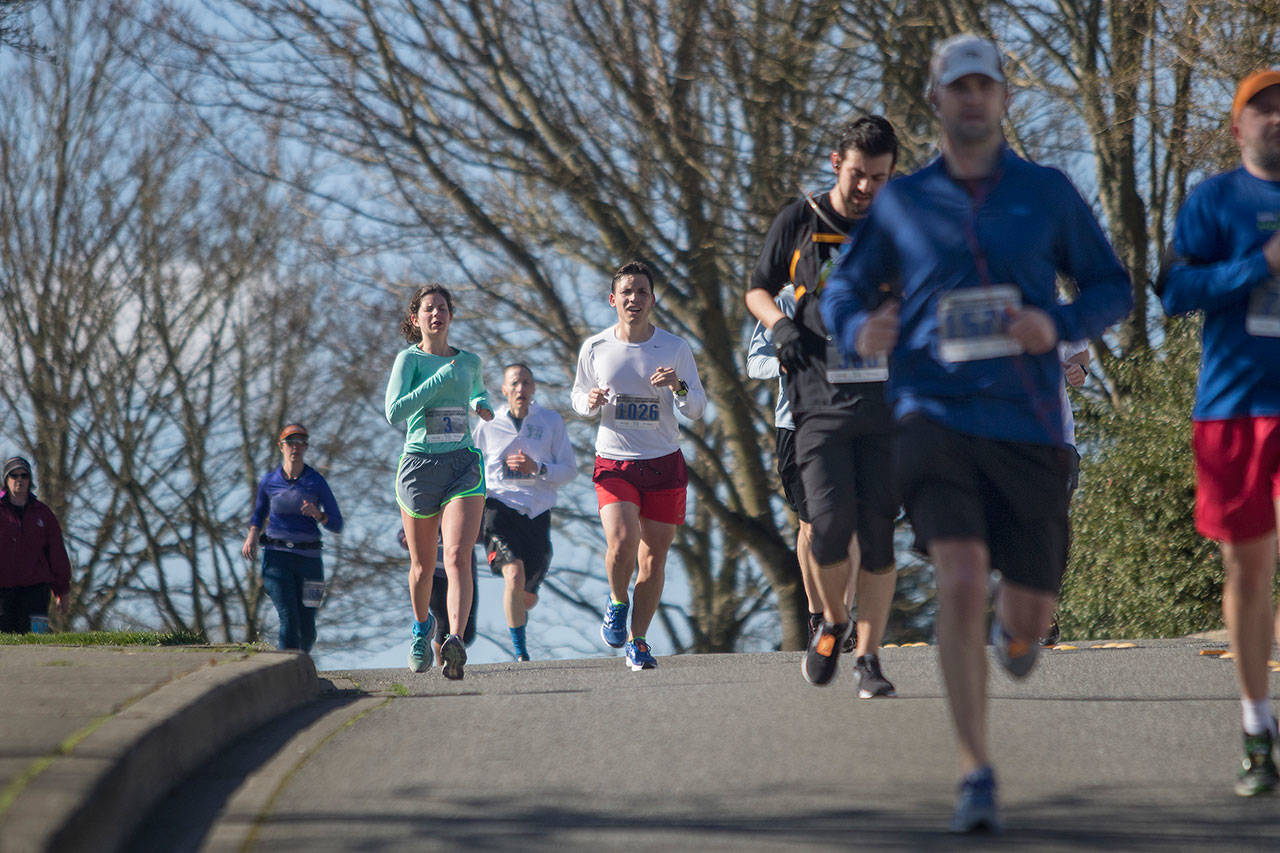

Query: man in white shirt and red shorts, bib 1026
[{"left": 572, "top": 261, "right": 707, "bottom": 671}]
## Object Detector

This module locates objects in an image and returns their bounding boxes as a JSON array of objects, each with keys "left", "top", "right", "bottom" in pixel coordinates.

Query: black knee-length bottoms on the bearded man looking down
[{"left": 796, "top": 410, "right": 899, "bottom": 573}]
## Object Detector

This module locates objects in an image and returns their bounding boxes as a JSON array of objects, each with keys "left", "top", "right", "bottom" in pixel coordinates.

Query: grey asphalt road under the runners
[{"left": 134, "top": 640, "right": 1280, "bottom": 853}]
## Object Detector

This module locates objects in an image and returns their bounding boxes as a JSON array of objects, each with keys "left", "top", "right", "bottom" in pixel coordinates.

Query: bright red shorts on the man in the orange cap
[{"left": 1192, "top": 416, "right": 1280, "bottom": 542}]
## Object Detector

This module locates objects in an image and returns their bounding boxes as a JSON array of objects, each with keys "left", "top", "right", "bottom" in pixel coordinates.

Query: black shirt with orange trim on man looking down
[{"left": 751, "top": 192, "right": 888, "bottom": 414}]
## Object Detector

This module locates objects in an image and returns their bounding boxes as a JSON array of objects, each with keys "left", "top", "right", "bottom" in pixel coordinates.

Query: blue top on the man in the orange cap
[{"left": 1158, "top": 167, "right": 1280, "bottom": 420}]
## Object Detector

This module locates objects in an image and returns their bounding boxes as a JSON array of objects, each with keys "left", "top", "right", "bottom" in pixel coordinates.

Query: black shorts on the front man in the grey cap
[{"left": 897, "top": 415, "right": 1069, "bottom": 594}]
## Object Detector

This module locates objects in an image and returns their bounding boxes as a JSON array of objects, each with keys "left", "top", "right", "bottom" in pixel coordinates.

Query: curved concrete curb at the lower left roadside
[{"left": 4, "top": 653, "right": 320, "bottom": 853}]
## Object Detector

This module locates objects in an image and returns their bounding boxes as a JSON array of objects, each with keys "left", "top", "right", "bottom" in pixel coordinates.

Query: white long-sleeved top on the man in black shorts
[{"left": 471, "top": 402, "right": 577, "bottom": 519}]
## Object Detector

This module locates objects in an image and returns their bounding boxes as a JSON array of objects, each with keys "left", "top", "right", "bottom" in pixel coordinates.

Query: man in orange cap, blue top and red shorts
[{"left": 1157, "top": 69, "right": 1280, "bottom": 797}]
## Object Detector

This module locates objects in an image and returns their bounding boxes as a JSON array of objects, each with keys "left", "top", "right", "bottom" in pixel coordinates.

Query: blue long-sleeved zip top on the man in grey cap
[{"left": 822, "top": 147, "right": 1133, "bottom": 444}]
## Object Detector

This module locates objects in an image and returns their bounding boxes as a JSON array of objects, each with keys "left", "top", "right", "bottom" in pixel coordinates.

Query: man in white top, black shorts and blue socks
[{"left": 472, "top": 364, "right": 577, "bottom": 661}]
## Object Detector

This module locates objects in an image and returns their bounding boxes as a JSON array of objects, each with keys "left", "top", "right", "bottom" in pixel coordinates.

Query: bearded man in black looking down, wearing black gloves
[{"left": 746, "top": 115, "right": 899, "bottom": 699}]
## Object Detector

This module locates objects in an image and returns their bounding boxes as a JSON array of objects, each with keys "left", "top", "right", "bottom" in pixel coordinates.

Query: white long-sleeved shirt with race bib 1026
[{"left": 570, "top": 325, "right": 707, "bottom": 459}]
